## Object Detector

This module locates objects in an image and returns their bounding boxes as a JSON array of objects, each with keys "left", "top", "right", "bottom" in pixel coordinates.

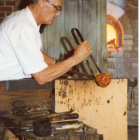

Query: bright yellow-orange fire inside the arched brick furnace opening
[{"left": 107, "top": 24, "right": 117, "bottom": 47}]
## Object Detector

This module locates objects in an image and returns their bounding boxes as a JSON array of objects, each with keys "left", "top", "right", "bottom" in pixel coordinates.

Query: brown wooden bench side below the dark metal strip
[{"left": 0, "top": 82, "right": 52, "bottom": 116}]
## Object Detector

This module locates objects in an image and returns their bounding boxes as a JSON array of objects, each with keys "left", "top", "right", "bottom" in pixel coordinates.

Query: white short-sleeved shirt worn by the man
[{"left": 0, "top": 7, "right": 48, "bottom": 81}]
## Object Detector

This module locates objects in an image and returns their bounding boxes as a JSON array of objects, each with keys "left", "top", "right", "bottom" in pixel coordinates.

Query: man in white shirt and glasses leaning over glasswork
[{"left": 0, "top": 0, "right": 92, "bottom": 85}]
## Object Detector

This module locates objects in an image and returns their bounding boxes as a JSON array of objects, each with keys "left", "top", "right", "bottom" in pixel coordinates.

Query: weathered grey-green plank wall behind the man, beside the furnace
[{"left": 42, "top": 0, "right": 107, "bottom": 73}]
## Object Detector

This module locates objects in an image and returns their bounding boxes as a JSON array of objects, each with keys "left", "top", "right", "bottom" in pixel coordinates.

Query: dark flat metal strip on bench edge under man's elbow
[{"left": 5, "top": 79, "right": 54, "bottom": 91}]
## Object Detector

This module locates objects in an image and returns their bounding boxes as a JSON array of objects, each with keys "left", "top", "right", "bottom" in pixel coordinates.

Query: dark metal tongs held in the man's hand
[{"left": 71, "top": 28, "right": 102, "bottom": 84}]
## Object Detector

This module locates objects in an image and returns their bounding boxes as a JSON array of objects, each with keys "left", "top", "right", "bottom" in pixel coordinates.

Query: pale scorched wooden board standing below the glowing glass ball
[{"left": 55, "top": 79, "right": 127, "bottom": 140}]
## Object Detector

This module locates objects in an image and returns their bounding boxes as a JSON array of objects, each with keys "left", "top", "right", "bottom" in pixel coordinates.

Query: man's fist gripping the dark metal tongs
[{"left": 73, "top": 40, "right": 92, "bottom": 63}]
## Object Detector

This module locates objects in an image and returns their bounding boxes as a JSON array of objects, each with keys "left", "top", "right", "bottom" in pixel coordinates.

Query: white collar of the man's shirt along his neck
[{"left": 25, "top": 6, "right": 41, "bottom": 30}]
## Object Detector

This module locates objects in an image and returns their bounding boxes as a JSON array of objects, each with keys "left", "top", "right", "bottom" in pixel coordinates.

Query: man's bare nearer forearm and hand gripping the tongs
[{"left": 32, "top": 41, "right": 92, "bottom": 85}]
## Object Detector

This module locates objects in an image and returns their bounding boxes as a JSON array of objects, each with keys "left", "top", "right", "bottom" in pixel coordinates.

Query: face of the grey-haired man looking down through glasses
[{"left": 41, "top": 0, "right": 62, "bottom": 25}]
